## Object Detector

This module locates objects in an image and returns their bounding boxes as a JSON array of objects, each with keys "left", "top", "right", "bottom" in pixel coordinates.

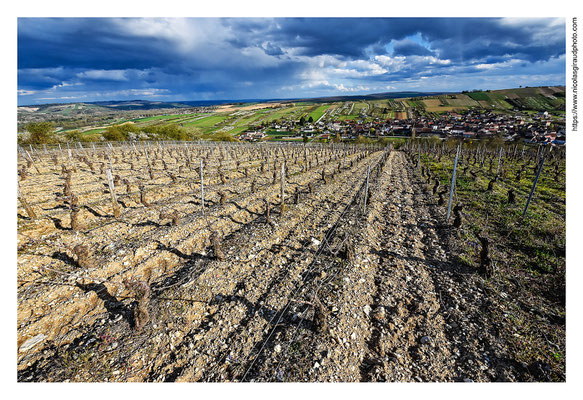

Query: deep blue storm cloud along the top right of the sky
[{"left": 225, "top": 18, "right": 565, "bottom": 61}]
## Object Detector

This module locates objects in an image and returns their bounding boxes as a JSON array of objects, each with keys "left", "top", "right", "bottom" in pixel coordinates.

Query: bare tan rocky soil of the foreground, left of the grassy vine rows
[{"left": 18, "top": 145, "right": 564, "bottom": 382}]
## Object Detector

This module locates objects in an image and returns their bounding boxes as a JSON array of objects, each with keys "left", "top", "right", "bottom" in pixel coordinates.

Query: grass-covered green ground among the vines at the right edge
[{"left": 422, "top": 143, "right": 566, "bottom": 380}]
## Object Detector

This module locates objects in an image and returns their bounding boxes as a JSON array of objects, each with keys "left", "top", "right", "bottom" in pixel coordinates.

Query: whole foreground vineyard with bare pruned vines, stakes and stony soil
[{"left": 17, "top": 140, "right": 565, "bottom": 382}]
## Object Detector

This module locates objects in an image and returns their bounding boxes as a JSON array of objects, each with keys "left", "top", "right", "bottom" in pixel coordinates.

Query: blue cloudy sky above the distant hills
[{"left": 17, "top": 18, "right": 566, "bottom": 105}]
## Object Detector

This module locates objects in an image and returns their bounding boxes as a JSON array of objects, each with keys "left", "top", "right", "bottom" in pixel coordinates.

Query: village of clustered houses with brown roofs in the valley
[{"left": 239, "top": 110, "right": 566, "bottom": 145}]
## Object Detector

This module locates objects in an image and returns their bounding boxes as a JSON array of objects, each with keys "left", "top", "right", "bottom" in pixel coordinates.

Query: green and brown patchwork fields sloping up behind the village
[{"left": 44, "top": 87, "right": 565, "bottom": 139}]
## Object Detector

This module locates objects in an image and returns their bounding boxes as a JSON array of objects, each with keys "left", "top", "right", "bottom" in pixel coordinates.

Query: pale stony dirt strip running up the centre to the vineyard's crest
[{"left": 244, "top": 152, "right": 455, "bottom": 382}]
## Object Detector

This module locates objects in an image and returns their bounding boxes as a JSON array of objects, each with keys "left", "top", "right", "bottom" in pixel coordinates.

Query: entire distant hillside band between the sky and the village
[{"left": 18, "top": 86, "right": 565, "bottom": 140}]
